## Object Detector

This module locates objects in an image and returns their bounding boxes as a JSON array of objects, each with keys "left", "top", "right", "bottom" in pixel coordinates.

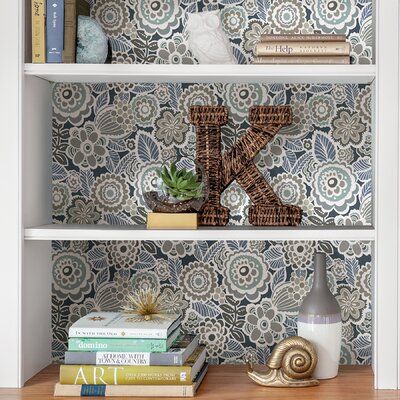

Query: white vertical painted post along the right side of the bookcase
[{"left": 374, "top": 0, "right": 399, "bottom": 389}]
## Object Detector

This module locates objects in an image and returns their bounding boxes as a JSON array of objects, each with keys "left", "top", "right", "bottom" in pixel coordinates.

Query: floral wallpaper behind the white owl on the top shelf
[{"left": 88, "top": 0, "right": 374, "bottom": 64}]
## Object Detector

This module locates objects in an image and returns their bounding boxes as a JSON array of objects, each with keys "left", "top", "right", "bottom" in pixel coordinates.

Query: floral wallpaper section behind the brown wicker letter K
[{"left": 52, "top": 83, "right": 372, "bottom": 225}]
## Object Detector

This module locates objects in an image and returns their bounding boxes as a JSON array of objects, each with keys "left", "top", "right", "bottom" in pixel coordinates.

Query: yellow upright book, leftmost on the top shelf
[{"left": 31, "top": 0, "right": 46, "bottom": 64}]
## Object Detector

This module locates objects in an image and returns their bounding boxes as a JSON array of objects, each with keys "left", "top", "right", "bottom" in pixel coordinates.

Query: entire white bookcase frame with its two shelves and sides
[{"left": 0, "top": 0, "right": 400, "bottom": 389}]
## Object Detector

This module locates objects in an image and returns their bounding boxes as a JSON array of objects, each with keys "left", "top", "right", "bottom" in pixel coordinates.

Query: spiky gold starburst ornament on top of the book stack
[{"left": 122, "top": 289, "right": 170, "bottom": 322}]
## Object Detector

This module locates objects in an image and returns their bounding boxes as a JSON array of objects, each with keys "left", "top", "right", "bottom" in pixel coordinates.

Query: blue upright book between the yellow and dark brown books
[{"left": 46, "top": 0, "right": 64, "bottom": 63}]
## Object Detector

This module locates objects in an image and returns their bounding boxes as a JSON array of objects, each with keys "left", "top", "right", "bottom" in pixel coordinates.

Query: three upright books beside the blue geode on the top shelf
[{"left": 31, "top": 0, "right": 90, "bottom": 63}]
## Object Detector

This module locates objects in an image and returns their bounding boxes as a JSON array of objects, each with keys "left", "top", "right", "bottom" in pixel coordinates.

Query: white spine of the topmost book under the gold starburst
[{"left": 68, "top": 326, "right": 168, "bottom": 339}]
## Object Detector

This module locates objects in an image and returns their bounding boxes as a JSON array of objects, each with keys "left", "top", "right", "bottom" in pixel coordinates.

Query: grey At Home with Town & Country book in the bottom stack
[{"left": 64, "top": 335, "right": 199, "bottom": 365}]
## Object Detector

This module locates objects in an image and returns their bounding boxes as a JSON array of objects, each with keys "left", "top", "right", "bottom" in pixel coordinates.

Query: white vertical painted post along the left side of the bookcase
[{"left": 0, "top": 1, "right": 23, "bottom": 387}]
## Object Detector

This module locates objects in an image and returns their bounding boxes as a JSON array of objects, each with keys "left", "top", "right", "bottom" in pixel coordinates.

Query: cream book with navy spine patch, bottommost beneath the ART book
[{"left": 54, "top": 363, "right": 208, "bottom": 397}]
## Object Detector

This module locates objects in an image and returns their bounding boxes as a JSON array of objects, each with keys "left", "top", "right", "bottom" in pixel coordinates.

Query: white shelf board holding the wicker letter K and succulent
[{"left": 25, "top": 224, "right": 375, "bottom": 241}]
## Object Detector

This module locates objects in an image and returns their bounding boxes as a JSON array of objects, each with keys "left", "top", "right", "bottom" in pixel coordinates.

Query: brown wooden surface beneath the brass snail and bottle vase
[{"left": 0, "top": 365, "right": 400, "bottom": 400}]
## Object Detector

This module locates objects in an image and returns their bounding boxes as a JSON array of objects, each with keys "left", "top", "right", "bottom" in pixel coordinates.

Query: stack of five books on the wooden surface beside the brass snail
[{"left": 54, "top": 312, "right": 208, "bottom": 397}]
